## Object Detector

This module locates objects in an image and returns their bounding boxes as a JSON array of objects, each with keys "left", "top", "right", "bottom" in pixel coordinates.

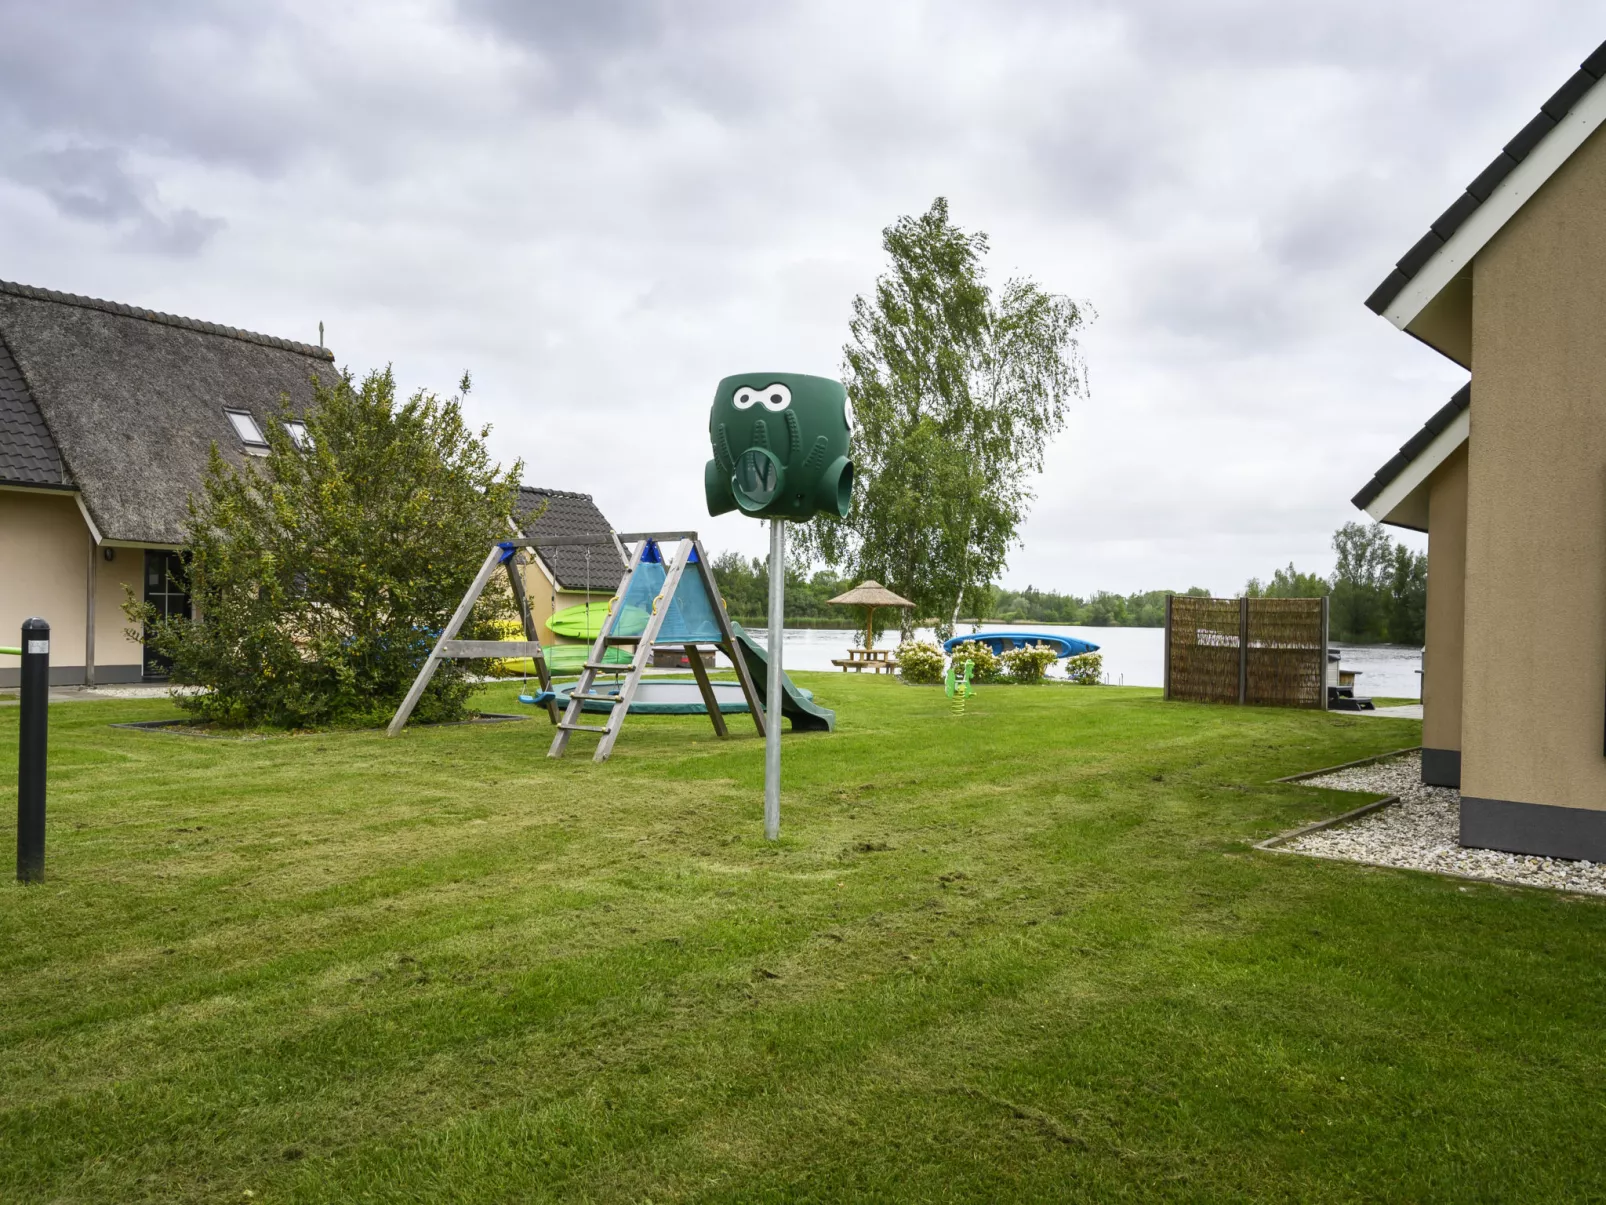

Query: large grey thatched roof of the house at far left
[{"left": 0, "top": 281, "right": 336, "bottom": 545}]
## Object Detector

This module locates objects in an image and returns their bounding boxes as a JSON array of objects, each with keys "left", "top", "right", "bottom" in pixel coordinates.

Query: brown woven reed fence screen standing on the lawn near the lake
[{"left": 1166, "top": 594, "right": 1327, "bottom": 709}]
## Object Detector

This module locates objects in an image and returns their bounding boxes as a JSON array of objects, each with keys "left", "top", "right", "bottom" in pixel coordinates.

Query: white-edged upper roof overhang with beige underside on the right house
[{"left": 1368, "top": 70, "right": 1606, "bottom": 361}]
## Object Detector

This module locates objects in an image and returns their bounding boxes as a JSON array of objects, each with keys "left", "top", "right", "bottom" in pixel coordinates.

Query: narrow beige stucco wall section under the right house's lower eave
[{"left": 1421, "top": 445, "right": 1466, "bottom": 749}]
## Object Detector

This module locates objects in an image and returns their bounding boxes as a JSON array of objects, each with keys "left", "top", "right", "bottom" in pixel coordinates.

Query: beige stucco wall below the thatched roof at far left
[{"left": 0, "top": 490, "right": 145, "bottom": 678}]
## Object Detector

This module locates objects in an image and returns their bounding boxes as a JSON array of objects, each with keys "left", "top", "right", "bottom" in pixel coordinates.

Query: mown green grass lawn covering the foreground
[{"left": 0, "top": 675, "right": 1606, "bottom": 1202}]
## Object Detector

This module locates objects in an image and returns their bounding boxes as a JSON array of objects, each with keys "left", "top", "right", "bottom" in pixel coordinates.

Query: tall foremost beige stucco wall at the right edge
[{"left": 1461, "top": 120, "right": 1606, "bottom": 810}]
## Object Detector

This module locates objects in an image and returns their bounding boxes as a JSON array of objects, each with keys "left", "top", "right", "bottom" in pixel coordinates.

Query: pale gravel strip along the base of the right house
[{"left": 1282, "top": 754, "right": 1606, "bottom": 895}]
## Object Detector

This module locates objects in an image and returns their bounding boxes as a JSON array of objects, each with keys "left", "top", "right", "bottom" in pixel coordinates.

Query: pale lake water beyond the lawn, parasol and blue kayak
[{"left": 735, "top": 623, "right": 1421, "bottom": 699}]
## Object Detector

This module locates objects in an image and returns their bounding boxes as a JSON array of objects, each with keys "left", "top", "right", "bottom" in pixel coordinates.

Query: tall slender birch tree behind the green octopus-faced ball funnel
[{"left": 797, "top": 198, "right": 1090, "bottom": 636}]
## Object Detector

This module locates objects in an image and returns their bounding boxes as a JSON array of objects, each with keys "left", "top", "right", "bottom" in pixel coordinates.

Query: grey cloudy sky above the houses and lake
[{"left": 0, "top": 0, "right": 1606, "bottom": 593}]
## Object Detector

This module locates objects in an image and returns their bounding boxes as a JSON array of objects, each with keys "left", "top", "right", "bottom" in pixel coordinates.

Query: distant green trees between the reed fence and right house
[{"left": 1243, "top": 522, "right": 1428, "bottom": 644}]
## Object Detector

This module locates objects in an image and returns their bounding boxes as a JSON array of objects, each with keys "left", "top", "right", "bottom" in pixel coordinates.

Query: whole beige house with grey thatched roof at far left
[{"left": 0, "top": 281, "right": 336, "bottom": 684}]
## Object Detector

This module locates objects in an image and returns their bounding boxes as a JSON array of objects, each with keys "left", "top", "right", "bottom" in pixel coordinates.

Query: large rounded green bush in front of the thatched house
[{"left": 125, "top": 368, "right": 522, "bottom": 728}]
